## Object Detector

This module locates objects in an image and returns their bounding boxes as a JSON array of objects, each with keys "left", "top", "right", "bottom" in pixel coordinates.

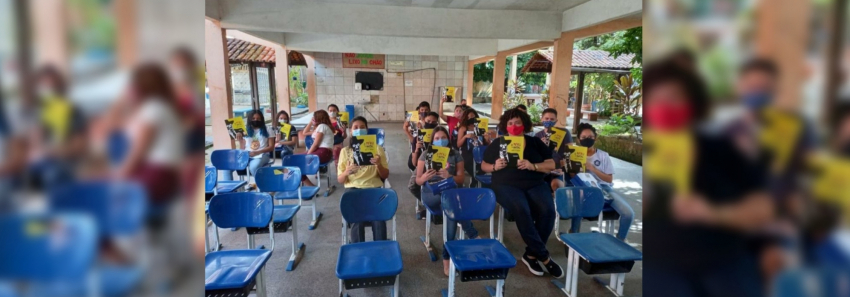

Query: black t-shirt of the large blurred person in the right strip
[{"left": 643, "top": 134, "right": 768, "bottom": 271}]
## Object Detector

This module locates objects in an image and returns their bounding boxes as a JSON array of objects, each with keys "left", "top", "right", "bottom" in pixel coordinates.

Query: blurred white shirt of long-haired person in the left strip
[{"left": 127, "top": 99, "right": 185, "bottom": 166}]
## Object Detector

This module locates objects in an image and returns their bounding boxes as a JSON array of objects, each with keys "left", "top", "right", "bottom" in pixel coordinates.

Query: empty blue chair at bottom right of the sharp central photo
[{"left": 552, "top": 187, "right": 643, "bottom": 296}]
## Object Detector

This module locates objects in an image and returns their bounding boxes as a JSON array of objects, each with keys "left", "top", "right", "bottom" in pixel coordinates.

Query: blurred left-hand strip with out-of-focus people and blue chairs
[{"left": 0, "top": 0, "right": 204, "bottom": 296}]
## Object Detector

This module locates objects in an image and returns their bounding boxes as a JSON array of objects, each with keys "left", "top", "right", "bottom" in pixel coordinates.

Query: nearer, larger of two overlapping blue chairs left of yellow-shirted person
[{"left": 255, "top": 167, "right": 304, "bottom": 271}]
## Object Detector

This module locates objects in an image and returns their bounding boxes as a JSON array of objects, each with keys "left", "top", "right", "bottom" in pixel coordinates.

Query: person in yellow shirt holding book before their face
[{"left": 336, "top": 117, "right": 390, "bottom": 242}]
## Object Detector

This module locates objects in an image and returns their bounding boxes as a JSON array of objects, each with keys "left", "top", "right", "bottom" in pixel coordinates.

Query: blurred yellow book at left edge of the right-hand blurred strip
[{"left": 643, "top": 131, "right": 695, "bottom": 196}]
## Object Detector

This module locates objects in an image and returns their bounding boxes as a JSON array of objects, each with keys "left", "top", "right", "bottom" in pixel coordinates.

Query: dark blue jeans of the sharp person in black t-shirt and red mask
[{"left": 492, "top": 180, "right": 555, "bottom": 260}]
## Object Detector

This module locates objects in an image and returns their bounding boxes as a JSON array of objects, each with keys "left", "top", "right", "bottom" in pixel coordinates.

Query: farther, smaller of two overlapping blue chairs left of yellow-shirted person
[{"left": 284, "top": 155, "right": 322, "bottom": 230}]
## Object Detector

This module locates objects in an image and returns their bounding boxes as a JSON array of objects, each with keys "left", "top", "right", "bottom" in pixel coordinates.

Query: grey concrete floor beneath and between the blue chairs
[{"left": 204, "top": 123, "right": 643, "bottom": 297}]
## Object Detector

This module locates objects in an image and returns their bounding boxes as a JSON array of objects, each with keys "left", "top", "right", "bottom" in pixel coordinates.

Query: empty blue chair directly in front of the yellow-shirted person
[{"left": 336, "top": 188, "right": 403, "bottom": 297}]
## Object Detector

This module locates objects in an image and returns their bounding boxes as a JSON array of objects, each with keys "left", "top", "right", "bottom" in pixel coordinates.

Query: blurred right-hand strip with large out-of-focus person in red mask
[{"left": 643, "top": 0, "right": 850, "bottom": 296}]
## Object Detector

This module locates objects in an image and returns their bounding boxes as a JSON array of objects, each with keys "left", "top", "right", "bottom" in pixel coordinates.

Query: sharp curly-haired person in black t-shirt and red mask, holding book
[{"left": 481, "top": 109, "right": 564, "bottom": 278}]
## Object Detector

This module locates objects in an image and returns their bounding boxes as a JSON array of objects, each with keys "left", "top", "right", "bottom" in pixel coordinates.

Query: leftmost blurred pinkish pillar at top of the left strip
[{"left": 29, "top": 0, "right": 70, "bottom": 74}]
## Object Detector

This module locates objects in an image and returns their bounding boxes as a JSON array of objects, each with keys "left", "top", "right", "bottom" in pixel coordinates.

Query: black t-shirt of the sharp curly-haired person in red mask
[{"left": 484, "top": 135, "right": 552, "bottom": 189}]
